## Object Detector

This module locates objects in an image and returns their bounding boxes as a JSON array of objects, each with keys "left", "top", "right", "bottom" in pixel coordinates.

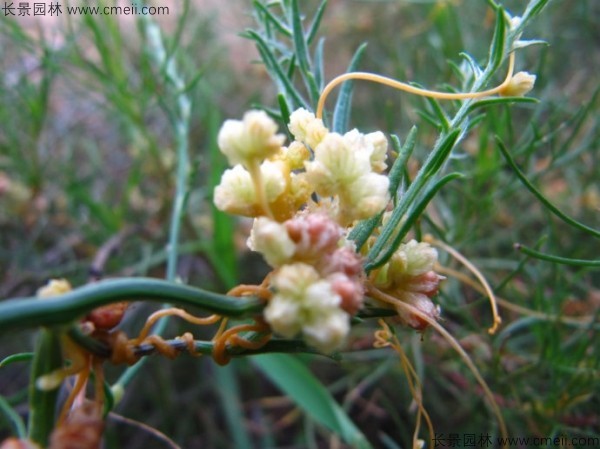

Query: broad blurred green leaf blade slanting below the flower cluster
[{"left": 252, "top": 354, "right": 371, "bottom": 449}]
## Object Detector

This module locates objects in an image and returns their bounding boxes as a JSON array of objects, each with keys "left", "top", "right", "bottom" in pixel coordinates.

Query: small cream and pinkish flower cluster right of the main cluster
[{"left": 372, "top": 240, "right": 444, "bottom": 330}]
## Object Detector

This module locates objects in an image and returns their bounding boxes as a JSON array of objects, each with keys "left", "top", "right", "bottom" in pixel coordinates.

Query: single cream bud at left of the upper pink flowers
[{"left": 248, "top": 217, "right": 296, "bottom": 267}]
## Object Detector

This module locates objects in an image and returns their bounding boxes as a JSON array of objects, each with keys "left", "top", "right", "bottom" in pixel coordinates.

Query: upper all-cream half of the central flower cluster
[{"left": 214, "top": 109, "right": 390, "bottom": 226}]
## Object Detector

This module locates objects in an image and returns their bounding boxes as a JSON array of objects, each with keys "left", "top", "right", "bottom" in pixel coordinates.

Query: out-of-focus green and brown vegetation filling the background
[{"left": 0, "top": 0, "right": 600, "bottom": 448}]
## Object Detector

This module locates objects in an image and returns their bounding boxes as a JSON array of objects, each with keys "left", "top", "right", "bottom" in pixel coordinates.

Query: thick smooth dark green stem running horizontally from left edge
[{"left": 0, "top": 278, "right": 264, "bottom": 332}]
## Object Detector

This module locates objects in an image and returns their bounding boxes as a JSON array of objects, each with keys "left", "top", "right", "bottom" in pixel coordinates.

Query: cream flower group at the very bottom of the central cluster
[{"left": 264, "top": 263, "right": 350, "bottom": 353}]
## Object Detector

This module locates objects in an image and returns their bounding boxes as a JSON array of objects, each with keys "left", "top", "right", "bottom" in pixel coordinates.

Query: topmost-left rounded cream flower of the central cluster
[{"left": 217, "top": 111, "right": 285, "bottom": 167}]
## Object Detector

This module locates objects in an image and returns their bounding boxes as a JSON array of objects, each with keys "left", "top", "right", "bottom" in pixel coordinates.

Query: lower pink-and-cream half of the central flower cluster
[{"left": 248, "top": 214, "right": 364, "bottom": 352}]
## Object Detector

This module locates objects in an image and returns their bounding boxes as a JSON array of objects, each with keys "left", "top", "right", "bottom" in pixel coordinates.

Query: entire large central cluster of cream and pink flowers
[{"left": 214, "top": 109, "right": 390, "bottom": 352}]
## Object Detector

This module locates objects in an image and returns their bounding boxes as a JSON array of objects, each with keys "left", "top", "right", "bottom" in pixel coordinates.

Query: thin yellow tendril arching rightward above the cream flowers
[{"left": 316, "top": 52, "right": 515, "bottom": 118}]
